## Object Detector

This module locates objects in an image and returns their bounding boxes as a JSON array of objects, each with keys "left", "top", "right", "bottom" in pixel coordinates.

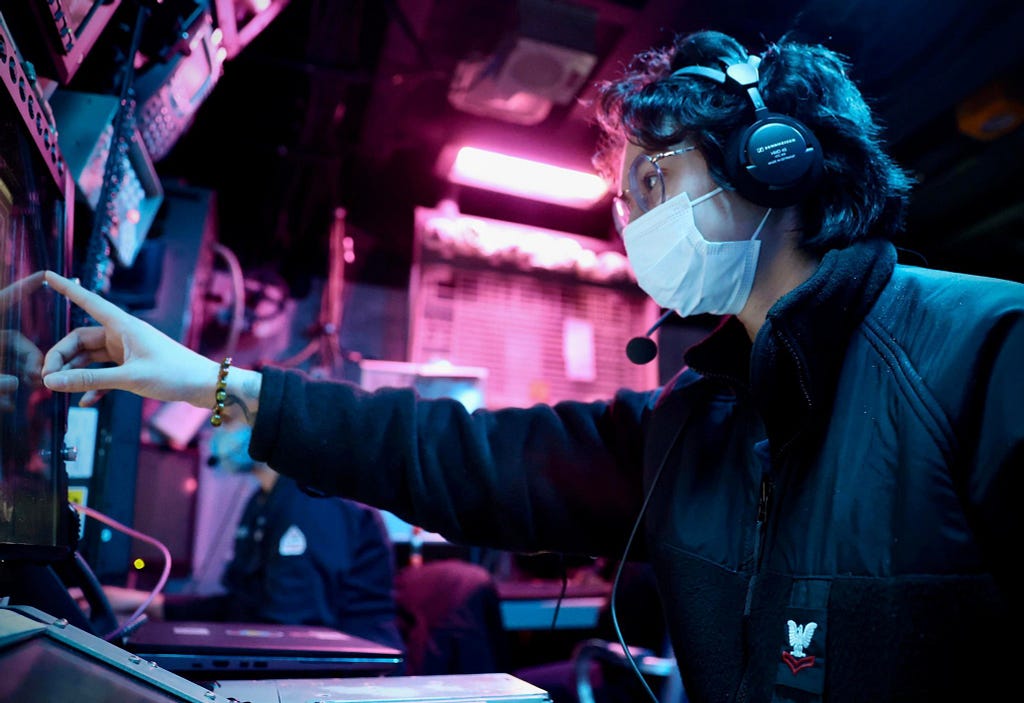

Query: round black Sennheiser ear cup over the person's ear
[{"left": 725, "top": 114, "right": 822, "bottom": 208}]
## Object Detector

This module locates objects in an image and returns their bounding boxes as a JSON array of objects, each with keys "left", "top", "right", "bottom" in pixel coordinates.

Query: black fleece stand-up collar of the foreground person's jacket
[{"left": 684, "top": 239, "right": 896, "bottom": 454}]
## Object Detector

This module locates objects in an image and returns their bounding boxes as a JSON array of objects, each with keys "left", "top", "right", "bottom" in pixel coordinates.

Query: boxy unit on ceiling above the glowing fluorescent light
[{"left": 449, "top": 0, "right": 597, "bottom": 125}]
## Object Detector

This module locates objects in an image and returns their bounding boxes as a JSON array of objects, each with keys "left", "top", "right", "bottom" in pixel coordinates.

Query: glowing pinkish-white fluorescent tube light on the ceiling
[{"left": 447, "top": 146, "right": 608, "bottom": 208}]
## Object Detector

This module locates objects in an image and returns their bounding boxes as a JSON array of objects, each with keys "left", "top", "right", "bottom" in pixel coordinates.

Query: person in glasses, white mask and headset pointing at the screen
[{"left": 43, "top": 31, "right": 1024, "bottom": 703}]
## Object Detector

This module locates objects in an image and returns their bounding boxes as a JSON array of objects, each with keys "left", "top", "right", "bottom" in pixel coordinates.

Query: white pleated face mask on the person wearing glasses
[{"left": 623, "top": 187, "right": 771, "bottom": 317}]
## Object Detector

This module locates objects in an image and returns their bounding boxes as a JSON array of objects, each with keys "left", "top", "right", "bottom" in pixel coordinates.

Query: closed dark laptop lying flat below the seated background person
[{"left": 124, "top": 620, "right": 403, "bottom": 678}]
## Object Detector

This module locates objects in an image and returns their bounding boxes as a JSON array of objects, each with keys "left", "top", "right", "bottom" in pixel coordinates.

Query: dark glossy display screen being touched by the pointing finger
[{"left": 0, "top": 72, "right": 72, "bottom": 560}]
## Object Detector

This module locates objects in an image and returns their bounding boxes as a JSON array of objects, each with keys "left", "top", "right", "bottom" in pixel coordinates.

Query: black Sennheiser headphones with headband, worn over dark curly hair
[{"left": 670, "top": 55, "right": 822, "bottom": 208}]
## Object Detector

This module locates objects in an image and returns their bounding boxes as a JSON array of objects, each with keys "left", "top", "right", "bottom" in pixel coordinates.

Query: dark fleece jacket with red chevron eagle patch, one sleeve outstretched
[{"left": 250, "top": 240, "right": 1024, "bottom": 703}]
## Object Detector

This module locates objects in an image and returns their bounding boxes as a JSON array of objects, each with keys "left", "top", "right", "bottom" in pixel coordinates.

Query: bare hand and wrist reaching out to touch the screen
[{"left": 42, "top": 271, "right": 262, "bottom": 425}]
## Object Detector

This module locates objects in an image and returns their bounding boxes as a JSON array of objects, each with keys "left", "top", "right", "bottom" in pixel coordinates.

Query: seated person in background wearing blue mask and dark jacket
[{"left": 103, "top": 423, "right": 404, "bottom": 650}]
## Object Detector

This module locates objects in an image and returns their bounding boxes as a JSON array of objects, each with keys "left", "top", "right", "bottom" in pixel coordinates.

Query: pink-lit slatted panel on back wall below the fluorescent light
[{"left": 410, "top": 261, "right": 656, "bottom": 407}]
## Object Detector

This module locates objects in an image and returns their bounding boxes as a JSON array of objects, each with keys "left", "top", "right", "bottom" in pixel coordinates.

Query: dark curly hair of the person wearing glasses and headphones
[{"left": 594, "top": 31, "right": 911, "bottom": 256}]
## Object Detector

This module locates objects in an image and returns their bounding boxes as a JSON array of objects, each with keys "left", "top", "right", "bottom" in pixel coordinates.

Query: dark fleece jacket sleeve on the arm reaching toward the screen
[{"left": 250, "top": 367, "right": 656, "bottom": 556}]
